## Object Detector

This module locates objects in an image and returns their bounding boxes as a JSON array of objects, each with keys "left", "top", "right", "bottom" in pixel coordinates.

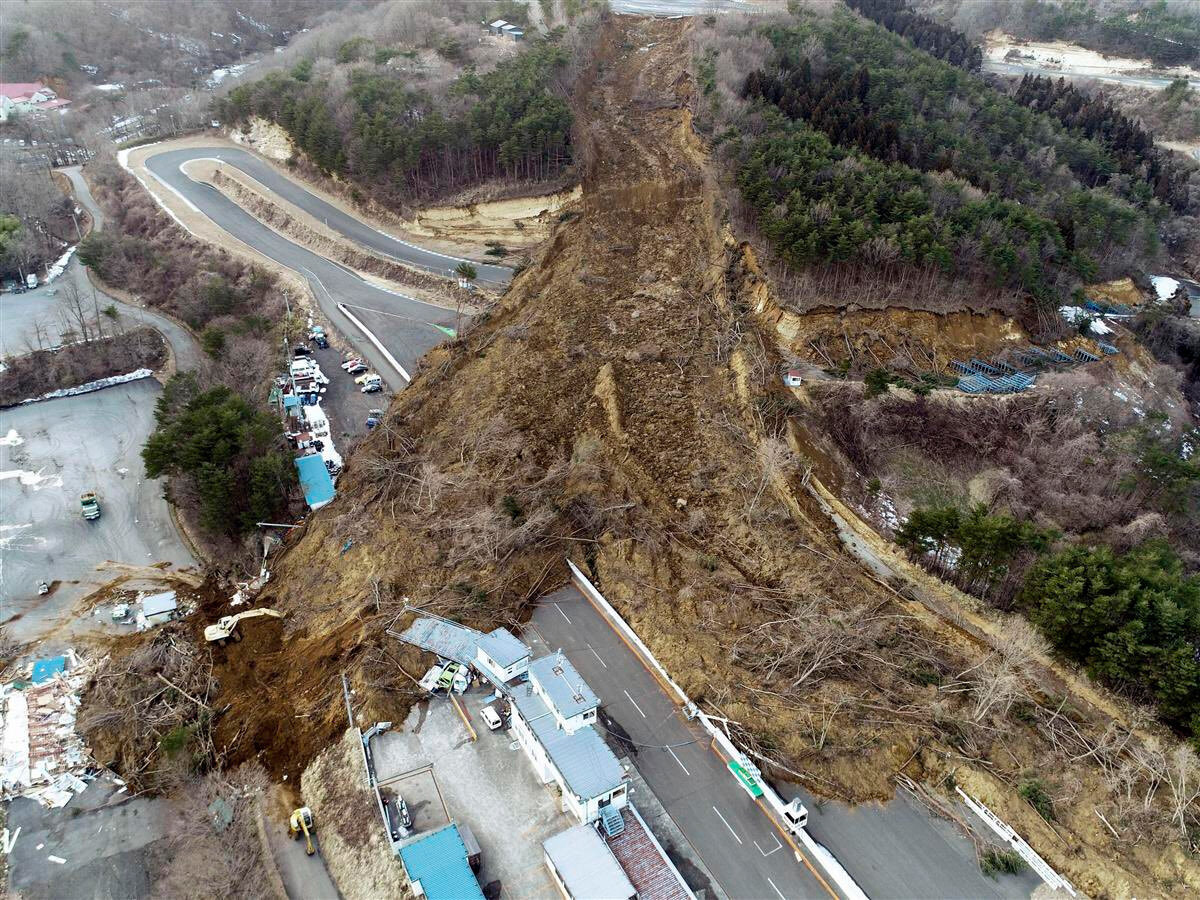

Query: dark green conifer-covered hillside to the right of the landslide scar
[{"left": 701, "top": 7, "right": 1171, "bottom": 328}]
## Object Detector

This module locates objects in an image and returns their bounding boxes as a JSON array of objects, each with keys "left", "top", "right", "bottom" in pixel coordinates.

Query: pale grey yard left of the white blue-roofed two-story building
[{"left": 371, "top": 689, "right": 576, "bottom": 900}]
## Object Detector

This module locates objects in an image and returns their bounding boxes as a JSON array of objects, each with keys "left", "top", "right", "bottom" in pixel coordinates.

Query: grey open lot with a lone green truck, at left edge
[{"left": 0, "top": 378, "right": 192, "bottom": 641}]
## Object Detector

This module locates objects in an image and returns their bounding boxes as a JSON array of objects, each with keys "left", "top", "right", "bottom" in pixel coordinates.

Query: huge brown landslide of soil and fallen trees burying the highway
[{"left": 204, "top": 16, "right": 1200, "bottom": 894}]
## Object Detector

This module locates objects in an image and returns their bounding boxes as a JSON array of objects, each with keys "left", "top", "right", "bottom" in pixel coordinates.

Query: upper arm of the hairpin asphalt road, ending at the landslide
[{"left": 146, "top": 146, "right": 512, "bottom": 284}]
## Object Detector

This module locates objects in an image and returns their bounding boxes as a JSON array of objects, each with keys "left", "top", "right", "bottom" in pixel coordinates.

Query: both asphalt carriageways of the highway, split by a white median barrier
[{"left": 526, "top": 587, "right": 1040, "bottom": 900}]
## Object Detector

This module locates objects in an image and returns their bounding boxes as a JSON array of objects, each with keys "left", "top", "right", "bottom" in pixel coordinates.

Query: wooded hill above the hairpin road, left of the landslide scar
[{"left": 221, "top": 4, "right": 592, "bottom": 204}]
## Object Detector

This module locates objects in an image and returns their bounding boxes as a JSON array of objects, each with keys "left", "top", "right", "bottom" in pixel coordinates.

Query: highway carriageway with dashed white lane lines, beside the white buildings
[{"left": 526, "top": 587, "right": 829, "bottom": 900}]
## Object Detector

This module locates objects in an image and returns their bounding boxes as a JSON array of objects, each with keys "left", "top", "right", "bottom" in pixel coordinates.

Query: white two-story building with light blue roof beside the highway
[{"left": 511, "top": 653, "right": 629, "bottom": 822}]
